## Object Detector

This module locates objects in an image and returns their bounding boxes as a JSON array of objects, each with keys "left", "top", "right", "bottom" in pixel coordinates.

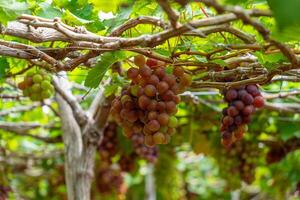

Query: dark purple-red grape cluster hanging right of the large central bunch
[{"left": 221, "top": 85, "right": 264, "bottom": 147}]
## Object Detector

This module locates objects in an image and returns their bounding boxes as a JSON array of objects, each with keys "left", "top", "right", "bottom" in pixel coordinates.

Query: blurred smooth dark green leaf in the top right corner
[{"left": 268, "top": 0, "right": 300, "bottom": 30}]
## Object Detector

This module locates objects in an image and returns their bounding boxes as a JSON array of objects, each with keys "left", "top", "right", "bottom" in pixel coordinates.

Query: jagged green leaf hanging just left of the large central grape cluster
[{"left": 84, "top": 51, "right": 126, "bottom": 88}]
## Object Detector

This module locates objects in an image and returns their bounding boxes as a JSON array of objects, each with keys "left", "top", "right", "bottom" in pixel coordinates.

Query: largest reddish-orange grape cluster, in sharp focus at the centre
[{"left": 111, "top": 55, "right": 192, "bottom": 146}]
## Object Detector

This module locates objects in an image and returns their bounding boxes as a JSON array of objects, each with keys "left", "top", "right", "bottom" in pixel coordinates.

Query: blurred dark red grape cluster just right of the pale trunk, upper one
[{"left": 98, "top": 122, "right": 118, "bottom": 164}]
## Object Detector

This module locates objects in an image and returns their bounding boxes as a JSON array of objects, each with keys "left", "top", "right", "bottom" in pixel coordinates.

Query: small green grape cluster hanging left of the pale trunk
[{"left": 18, "top": 69, "right": 54, "bottom": 101}]
